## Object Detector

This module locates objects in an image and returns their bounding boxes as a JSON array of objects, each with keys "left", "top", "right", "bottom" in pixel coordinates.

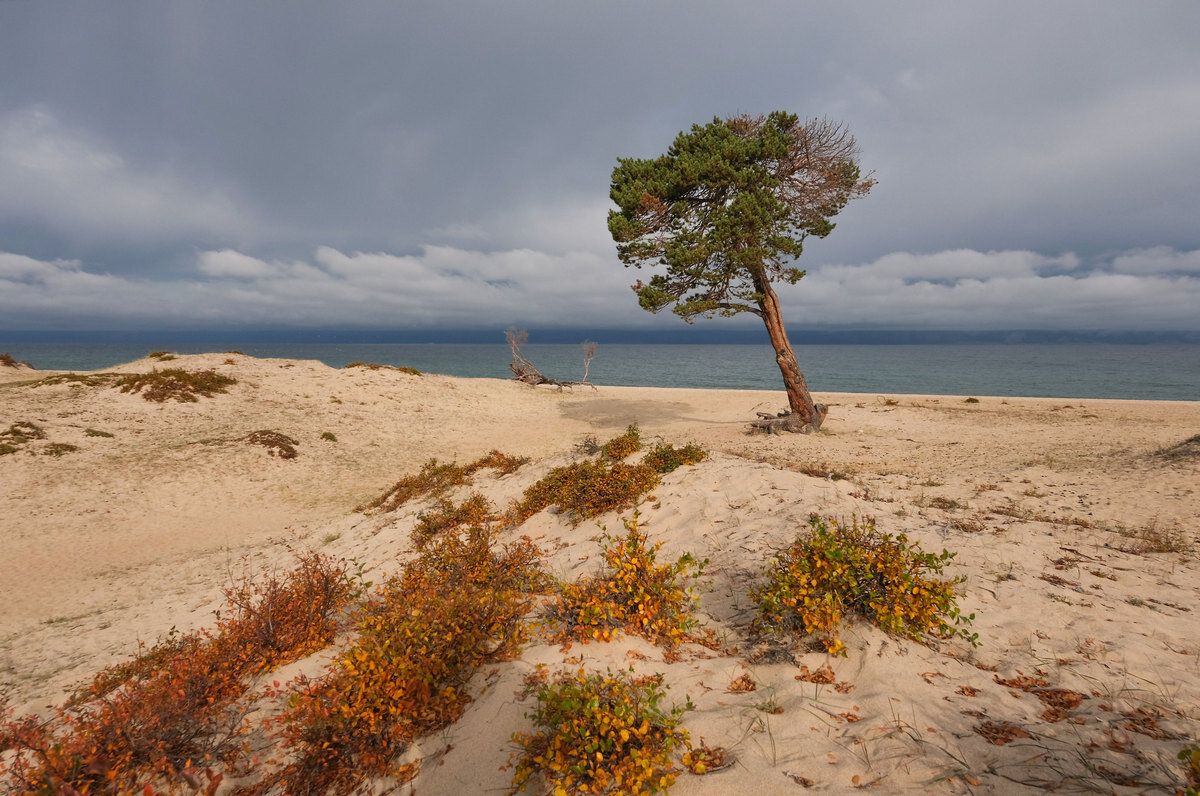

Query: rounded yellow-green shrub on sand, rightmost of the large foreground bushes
[{"left": 750, "top": 515, "right": 976, "bottom": 654}]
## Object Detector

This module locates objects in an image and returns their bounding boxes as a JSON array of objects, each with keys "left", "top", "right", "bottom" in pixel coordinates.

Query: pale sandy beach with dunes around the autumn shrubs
[{"left": 0, "top": 353, "right": 1200, "bottom": 795}]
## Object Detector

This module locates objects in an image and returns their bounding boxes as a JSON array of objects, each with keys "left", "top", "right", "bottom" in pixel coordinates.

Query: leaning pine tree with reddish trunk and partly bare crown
[{"left": 608, "top": 110, "right": 875, "bottom": 432}]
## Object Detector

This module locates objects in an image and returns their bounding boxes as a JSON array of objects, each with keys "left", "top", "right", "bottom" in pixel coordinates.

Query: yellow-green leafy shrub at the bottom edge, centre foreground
[{"left": 512, "top": 669, "right": 689, "bottom": 794}]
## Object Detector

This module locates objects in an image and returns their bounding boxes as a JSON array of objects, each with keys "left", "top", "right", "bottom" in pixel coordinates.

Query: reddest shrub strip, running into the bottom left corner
[{"left": 0, "top": 553, "right": 352, "bottom": 794}]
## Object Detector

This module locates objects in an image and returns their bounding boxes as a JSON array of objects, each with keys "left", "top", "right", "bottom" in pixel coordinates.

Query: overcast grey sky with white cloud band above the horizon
[{"left": 0, "top": 0, "right": 1200, "bottom": 330}]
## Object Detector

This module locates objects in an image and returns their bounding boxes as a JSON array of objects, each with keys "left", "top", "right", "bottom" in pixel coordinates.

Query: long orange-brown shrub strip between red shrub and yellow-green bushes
[{"left": 275, "top": 526, "right": 541, "bottom": 794}]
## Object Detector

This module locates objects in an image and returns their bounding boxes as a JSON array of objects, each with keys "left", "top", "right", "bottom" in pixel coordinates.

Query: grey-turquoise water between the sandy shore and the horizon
[{"left": 0, "top": 339, "right": 1200, "bottom": 401}]
